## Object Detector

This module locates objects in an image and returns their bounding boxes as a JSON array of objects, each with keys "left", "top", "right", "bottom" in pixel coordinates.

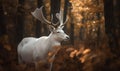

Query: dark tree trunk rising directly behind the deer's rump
[{"left": 16, "top": 0, "right": 24, "bottom": 43}]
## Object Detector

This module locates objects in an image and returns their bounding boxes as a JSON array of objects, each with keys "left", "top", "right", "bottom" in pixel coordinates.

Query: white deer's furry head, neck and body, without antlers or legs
[{"left": 17, "top": 28, "right": 69, "bottom": 70}]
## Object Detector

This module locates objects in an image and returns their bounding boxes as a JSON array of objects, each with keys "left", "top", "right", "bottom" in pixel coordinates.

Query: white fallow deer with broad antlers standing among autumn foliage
[{"left": 17, "top": 6, "right": 69, "bottom": 71}]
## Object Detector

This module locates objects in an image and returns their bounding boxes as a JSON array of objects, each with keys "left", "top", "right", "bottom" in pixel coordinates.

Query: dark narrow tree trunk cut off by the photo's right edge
[{"left": 114, "top": 0, "right": 120, "bottom": 48}]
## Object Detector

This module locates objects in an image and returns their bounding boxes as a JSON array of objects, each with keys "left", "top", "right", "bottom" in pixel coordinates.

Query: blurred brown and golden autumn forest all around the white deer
[{"left": 0, "top": 0, "right": 120, "bottom": 71}]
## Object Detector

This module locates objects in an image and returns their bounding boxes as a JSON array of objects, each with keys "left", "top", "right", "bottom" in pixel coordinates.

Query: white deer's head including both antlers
[{"left": 32, "top": 6, "right": 69, "bottom": 41}]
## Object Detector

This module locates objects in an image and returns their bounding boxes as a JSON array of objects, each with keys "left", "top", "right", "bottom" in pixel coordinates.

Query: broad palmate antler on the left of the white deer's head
[{"left": 32, "top": 6, "right": 59, "bottom": 28}]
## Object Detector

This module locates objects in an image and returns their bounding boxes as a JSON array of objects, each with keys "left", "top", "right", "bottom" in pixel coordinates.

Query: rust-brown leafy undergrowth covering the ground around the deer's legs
[{"left": 0, "top": 40, "right": 120, "bottom": 71}]
